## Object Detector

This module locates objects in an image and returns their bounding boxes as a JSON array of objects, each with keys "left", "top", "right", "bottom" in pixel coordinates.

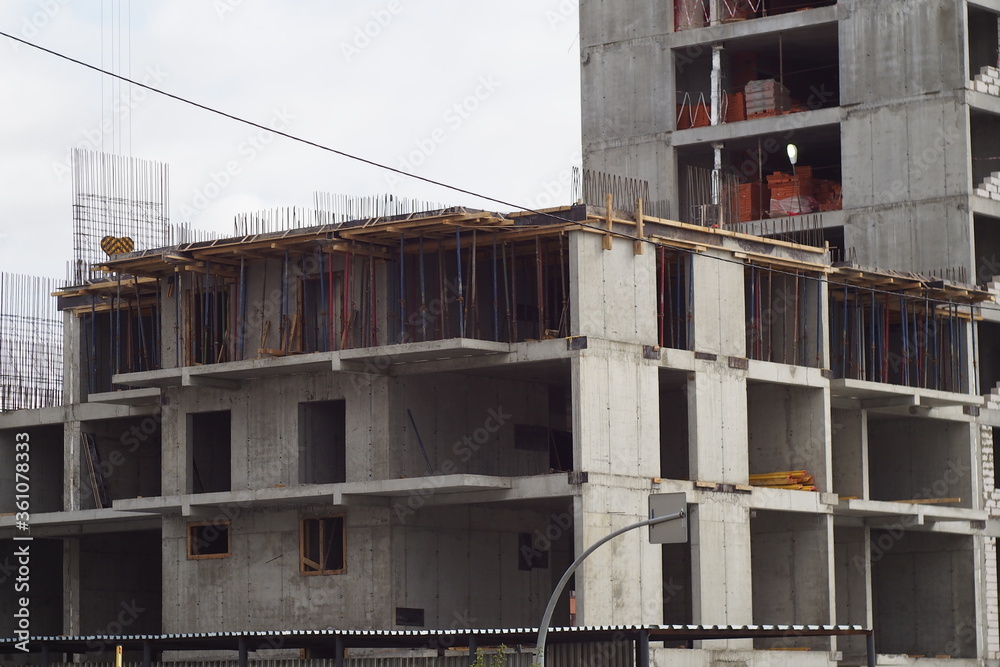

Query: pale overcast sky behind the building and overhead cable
[{"left": 0, "top": 0, "right": 580, "bottom": 278}]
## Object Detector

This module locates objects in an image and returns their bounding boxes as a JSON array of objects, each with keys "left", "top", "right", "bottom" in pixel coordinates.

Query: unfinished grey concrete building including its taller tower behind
[{"left": 0, "top": 0, "right": 1000, "bottom": 667}]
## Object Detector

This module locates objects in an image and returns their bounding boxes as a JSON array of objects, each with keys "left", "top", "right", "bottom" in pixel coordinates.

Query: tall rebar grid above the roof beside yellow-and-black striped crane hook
[{"left": 71, "top": 148, "right": 171, "bottom": 284}]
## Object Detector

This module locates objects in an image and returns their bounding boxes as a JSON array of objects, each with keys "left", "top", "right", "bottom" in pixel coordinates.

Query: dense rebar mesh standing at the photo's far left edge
[{"left": 0, "top": 273, "right": 63, "bottom": 412}]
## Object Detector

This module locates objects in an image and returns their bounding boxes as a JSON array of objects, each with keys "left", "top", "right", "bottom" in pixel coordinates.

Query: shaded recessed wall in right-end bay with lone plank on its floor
[{"left": 868, "top": 417, "right": 982, "bottom": 507}]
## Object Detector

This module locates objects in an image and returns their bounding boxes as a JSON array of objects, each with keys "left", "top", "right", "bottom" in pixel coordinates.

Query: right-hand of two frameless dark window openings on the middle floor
[{"left": 299, "top": 401, "right": 347, "bottom": 484}]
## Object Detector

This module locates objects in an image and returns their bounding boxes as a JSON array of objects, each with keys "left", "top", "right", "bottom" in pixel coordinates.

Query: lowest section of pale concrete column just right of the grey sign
[{"left": 689, "top": 501, "right": 753, "bottom": 648}]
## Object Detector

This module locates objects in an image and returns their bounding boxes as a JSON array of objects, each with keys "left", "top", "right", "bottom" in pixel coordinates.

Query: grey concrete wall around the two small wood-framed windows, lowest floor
[{"left": 162, "top": 504, "right": 393, "bottom": 632}]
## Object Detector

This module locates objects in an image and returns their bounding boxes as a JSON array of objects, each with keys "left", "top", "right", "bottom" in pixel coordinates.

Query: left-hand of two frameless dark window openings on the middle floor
[{"left": 187, "top": 410, "right": 232, "bottom": 493}]
